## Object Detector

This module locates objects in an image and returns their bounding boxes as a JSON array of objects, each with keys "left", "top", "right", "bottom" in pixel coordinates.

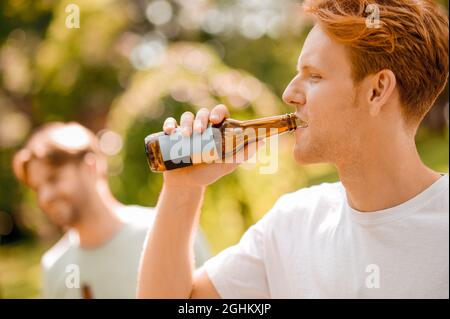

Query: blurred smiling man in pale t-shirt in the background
[{"left": 13, "top": 122, "right": 209, "bottom": 298}]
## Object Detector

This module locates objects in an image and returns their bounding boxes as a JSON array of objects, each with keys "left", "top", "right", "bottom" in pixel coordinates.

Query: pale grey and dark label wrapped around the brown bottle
[{"left": 158, "top": 126, "right": 222, "bottom": 169}]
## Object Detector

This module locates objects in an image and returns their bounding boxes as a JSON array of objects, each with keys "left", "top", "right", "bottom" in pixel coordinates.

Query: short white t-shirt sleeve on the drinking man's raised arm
[{"left": 203, "top": 211, "right": 272, "bottom": 299}]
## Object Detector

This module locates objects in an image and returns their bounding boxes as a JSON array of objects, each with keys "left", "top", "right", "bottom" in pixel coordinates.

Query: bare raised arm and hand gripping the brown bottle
[{"left": 137, "top": 105, "right": 237, "bottom": 298}]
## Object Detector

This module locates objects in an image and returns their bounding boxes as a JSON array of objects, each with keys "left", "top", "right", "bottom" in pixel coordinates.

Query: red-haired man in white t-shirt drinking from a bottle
[{"left": 138, "top": 0, "right": 449, "bottom": 298}]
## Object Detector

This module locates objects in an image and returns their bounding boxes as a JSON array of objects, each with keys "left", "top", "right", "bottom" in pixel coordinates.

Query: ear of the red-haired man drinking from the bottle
[{"left": 367, "top": 69, "right": 397, "bottom": 116}]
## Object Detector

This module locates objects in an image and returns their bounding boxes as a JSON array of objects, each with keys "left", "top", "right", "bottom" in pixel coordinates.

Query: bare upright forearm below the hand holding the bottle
[{"left": 137, "top": 185, "right": 204, "bottom": 298}]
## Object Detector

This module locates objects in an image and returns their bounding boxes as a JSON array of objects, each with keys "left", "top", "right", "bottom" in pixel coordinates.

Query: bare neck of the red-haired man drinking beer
[{"left": 336, "top": 132, "right": 440, "bottom": 212}]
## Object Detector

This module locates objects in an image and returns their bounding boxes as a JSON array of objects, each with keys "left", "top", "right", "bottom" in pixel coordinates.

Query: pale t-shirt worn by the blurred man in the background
[{"left": 41, "top": 206, "right": 209, "bottom": 298}]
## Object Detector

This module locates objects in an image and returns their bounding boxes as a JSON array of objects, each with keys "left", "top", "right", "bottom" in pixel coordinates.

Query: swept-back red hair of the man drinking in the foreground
[{"left": 304, "top": 0, "right": 449, "bottom": 124}]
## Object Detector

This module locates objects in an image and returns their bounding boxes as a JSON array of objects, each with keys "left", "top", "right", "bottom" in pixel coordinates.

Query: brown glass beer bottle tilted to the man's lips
[{"left": 145, "top": 113, "right": 307, "bottom": 172}]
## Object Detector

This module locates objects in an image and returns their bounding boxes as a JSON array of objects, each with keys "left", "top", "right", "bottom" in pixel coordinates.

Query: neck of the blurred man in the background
[{"left": 74, "top": 188, "right": 123, "bottom": 249}]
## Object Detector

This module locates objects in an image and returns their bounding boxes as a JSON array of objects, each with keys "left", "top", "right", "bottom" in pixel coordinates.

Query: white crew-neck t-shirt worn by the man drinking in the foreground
[{"left": 204, "top": 175, "right": 449, "bottom": 298}]
